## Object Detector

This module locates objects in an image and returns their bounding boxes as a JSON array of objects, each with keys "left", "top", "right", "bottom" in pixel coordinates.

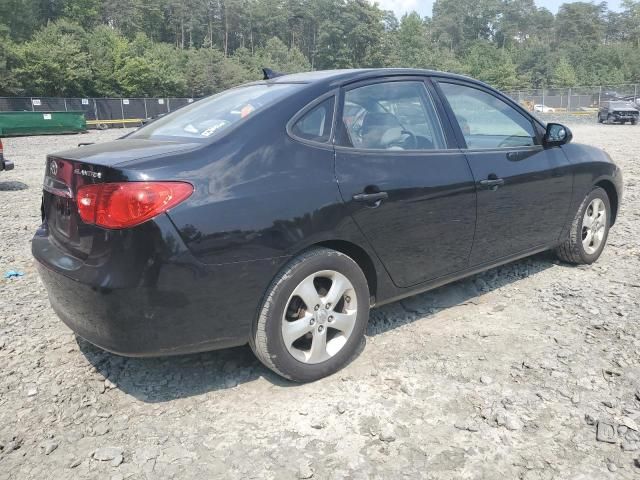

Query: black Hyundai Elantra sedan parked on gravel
[{"left": 32, "top": 69, "right": 622, "bottom": 381}]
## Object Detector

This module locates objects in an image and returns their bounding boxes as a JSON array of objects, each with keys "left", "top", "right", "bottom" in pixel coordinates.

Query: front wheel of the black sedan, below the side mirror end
[{"left": 556, "top": 187, "right": 611, "bottom": 265}]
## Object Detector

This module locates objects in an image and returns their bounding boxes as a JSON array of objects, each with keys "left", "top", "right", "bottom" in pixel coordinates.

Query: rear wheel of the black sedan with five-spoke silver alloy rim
[{"left": 249, "top": 248, "right": 369, "bottom": 383}]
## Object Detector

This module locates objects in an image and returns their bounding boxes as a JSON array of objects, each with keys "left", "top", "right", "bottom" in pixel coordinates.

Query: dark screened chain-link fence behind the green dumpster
[{"left": 0, "top": 97, "right": 194, "bottom": 128}]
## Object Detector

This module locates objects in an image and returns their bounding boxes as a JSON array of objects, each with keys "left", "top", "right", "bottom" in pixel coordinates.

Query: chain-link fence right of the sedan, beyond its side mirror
[{"left": 506, "top": 84, "right": 640, "bottom": 115}]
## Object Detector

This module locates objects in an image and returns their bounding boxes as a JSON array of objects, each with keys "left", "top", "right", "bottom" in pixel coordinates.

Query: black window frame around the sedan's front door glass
[{"left": 433, "top": 77, "right": 544, "bottom": 153}]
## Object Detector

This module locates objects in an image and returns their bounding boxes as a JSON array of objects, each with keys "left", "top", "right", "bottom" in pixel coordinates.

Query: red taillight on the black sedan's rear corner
[{"left": 76, "top": 182, "right": 193, "bottom": 228}]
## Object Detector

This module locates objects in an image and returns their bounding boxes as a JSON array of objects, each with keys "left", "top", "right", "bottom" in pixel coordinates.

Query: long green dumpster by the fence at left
[{"left": 0, "top": 112, "right": 87, "bottom": 137}]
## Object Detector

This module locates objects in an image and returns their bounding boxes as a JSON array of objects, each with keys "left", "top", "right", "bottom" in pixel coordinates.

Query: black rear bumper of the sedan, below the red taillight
[{"left": 32, "top": 216, "right": 277, "bottom": 356}]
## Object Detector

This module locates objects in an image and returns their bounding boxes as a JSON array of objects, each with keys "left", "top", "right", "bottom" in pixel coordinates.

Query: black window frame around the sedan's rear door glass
[{"left": 334, "top": 75, "right": 452, "bottom": 156}]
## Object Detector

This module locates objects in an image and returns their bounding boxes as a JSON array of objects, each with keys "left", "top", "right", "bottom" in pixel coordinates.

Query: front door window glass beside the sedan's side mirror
[{"left": 440, "top": 83, "right": 536, "bottom": 149}]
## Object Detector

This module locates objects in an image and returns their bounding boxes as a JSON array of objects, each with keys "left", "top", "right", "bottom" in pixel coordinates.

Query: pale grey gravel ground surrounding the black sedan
[{"left": 0, "top": 124, "right": 640, "bottom": 479}]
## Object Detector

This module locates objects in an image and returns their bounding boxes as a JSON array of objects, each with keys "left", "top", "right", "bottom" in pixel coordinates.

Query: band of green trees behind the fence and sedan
[{"left": 0, "top": 0, "right": 640, "bottom": 97}]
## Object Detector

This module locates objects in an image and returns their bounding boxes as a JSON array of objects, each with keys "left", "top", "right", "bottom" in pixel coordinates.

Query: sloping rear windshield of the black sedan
[{"left": 129, "top": 83, "right": 302, "bottom": 140}]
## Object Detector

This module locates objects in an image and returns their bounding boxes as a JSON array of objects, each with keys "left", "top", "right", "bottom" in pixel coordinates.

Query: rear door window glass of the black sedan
[{"left": 341, "top": 81, "right": 446, "bottom": 150}]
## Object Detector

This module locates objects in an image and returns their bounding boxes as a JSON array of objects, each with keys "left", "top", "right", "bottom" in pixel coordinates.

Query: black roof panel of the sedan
[{"left": 255, "top": 68, "right": 488, "bottom": 86}]
